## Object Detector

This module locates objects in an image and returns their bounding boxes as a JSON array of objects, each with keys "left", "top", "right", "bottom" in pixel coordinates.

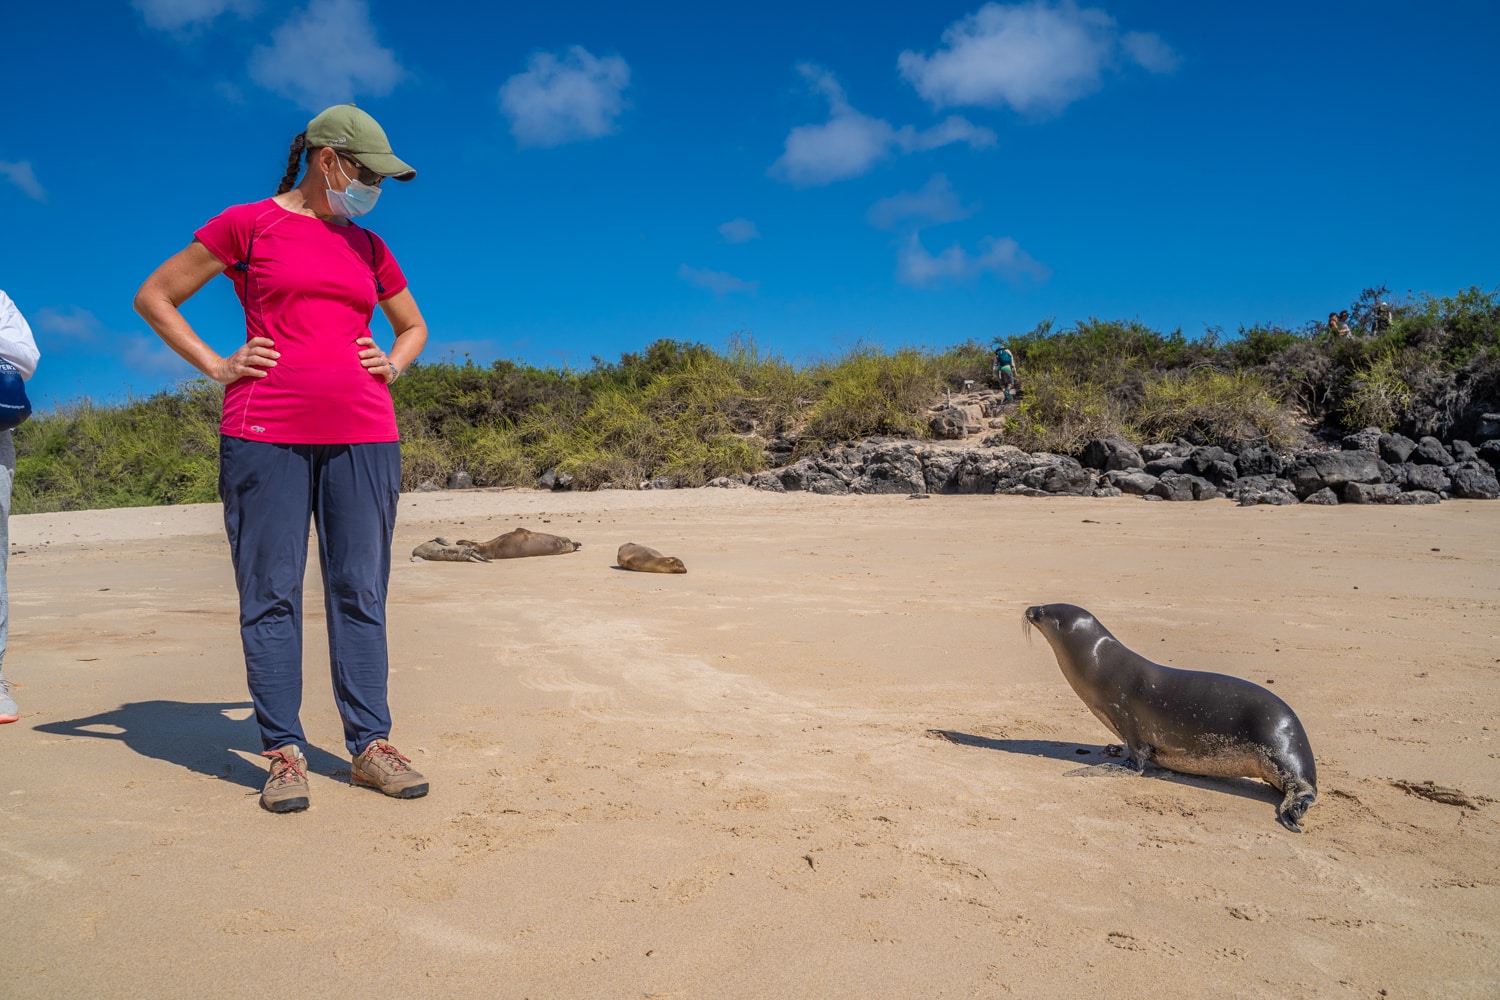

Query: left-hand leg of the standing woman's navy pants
[{"left": 219, "top": 436, "right": 312, "bottom": 750}]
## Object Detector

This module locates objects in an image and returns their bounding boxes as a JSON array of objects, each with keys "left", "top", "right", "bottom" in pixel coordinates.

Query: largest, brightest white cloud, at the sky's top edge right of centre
[{"left": 896, "top": 0, "right": 1179, "bottom": 114}]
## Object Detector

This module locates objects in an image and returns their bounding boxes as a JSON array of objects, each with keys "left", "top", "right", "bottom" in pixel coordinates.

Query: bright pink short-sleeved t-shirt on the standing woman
[{"left": 194, "top": 198, "right": 407, "bottom": 444}]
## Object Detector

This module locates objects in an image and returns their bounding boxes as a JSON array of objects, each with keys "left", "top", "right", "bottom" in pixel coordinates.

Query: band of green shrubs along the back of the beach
[{"left": 14, "top": 288, "right": 1500, "bottom": 513}]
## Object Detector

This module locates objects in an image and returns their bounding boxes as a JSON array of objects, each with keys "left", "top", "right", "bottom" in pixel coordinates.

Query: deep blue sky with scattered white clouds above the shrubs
[{"left": 0, "top": 0, "right": 1500, "bottom": 406}]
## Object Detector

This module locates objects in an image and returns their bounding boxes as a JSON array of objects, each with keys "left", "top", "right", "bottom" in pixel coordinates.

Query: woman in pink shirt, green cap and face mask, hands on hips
[{"left": 135, "top": 105, "right": 428, "bottom": 813}]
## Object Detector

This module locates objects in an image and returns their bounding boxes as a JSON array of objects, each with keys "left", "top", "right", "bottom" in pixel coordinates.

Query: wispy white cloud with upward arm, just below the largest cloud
[{"left": 770, "top": 64, "right": 995, "bottom": 187}]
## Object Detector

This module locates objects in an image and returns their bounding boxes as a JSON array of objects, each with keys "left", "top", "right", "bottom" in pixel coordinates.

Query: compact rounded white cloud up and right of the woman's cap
[{"left": 500, "top": 45, "right": 630, "bottom": 147}]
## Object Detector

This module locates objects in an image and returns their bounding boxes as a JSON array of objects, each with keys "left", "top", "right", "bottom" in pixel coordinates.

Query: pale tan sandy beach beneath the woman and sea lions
[{"left": 0, "top": 489, "right": 1500, "bottom": 999}]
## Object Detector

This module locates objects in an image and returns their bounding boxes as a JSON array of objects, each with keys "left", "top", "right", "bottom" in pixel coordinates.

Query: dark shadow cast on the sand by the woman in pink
[{"left": 33, "top": 702, "right": 350, "bottom": 790}]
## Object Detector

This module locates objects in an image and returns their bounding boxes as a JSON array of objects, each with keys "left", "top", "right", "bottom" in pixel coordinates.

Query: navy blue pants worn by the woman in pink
[{"left": 219, "top": 436, "right": 401, "bottom": 754}]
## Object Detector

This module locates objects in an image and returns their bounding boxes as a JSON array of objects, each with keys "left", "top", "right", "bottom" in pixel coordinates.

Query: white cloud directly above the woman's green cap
[{"left": 249, "top": 0, "right": 407, "bottom": 111}]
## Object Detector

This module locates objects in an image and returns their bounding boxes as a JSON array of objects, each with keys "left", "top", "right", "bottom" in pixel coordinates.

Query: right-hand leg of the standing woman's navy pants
[{"left": 314, "top": 441, "right": 401, "bottom": 757}]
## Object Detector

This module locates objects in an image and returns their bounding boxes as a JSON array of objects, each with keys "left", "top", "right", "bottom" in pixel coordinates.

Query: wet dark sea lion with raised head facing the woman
[{"left": 1026, "top": 604, "right": 1317, "bottom": 834}]
